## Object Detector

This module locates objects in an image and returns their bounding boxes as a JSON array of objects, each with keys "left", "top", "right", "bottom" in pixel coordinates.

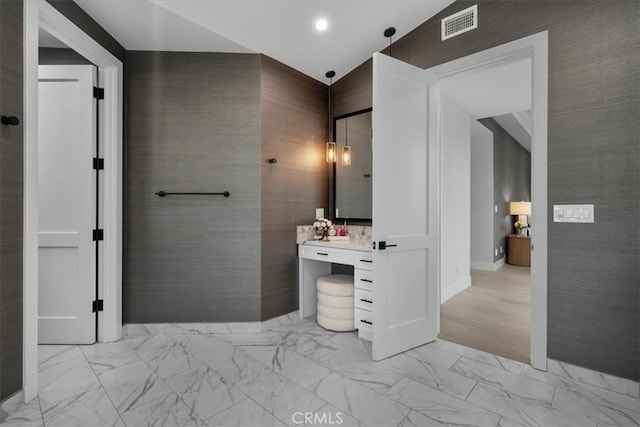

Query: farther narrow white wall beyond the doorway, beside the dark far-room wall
[{"left": 470, "top": 120, "right": 494, "bottom": 270}]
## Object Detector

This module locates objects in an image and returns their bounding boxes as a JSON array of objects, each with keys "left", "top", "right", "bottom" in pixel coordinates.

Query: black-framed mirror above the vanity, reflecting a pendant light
[{"left": 333, "top": 108, "right": 372, "bottom": 221}]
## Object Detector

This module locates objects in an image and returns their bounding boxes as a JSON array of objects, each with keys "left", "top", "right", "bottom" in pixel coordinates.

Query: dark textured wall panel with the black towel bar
[{"left": 124, "top": 52, "right": 262, "bottom": 323}]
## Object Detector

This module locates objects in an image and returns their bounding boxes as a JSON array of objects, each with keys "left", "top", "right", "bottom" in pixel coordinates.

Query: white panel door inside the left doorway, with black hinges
[{"left": 38, "top": 65, "right": 96, "bottom": 344}]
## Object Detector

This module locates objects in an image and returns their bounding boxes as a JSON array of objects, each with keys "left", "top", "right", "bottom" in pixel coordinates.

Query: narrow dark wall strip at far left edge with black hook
[{"left": 0, "top": 0, "right": 24, "bottom": 402}]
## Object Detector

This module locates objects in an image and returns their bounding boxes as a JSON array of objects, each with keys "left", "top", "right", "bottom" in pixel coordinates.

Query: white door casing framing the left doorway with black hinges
[{"left": 23, "top": 0, "right": 124, "bottom": 402}]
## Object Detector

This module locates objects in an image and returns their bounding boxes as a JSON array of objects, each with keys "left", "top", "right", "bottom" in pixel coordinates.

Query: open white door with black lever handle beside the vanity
[{"left": 372, "top": 53, "right": 440, "bottom": 361}]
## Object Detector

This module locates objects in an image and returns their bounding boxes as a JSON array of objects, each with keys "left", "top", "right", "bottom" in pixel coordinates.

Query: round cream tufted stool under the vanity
[{"left": 316, "top": 274, "right": 355, "bottom": 332}]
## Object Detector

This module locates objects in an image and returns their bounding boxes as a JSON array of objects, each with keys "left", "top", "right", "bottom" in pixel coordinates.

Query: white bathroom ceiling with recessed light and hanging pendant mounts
[{"left": 76, "top": 0, "right": 453, "bottom": 83}]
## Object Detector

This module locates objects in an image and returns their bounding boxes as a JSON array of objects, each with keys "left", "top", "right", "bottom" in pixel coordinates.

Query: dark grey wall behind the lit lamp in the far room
[{"left": 478, "top": 118, "right": 534, "bottom": 262}]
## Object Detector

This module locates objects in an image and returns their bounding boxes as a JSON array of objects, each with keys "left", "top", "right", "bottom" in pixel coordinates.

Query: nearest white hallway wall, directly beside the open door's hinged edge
[{"left": 440, "top": 93, "right": 471, "bottom": 302}]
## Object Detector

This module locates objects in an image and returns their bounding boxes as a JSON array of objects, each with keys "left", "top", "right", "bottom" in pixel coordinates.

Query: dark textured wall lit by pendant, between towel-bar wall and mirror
[{"left": 260, "top": 56, "right": 328, "bottom": 320}]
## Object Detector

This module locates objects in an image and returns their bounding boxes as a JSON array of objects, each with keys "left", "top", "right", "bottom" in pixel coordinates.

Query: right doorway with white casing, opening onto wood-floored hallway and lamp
[{"left": 430, "top": 32, "right": 548, "bottom": 370}]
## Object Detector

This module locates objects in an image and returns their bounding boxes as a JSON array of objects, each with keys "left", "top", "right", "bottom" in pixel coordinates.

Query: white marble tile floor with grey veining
[{"left": 0, "top": 319, "right": 640, "bottom": 427}]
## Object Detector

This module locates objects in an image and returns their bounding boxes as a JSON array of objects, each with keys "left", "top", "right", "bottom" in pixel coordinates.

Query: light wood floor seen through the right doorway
[{"left": 439, "top": 264, "right": 531, "bottom": 363}]
